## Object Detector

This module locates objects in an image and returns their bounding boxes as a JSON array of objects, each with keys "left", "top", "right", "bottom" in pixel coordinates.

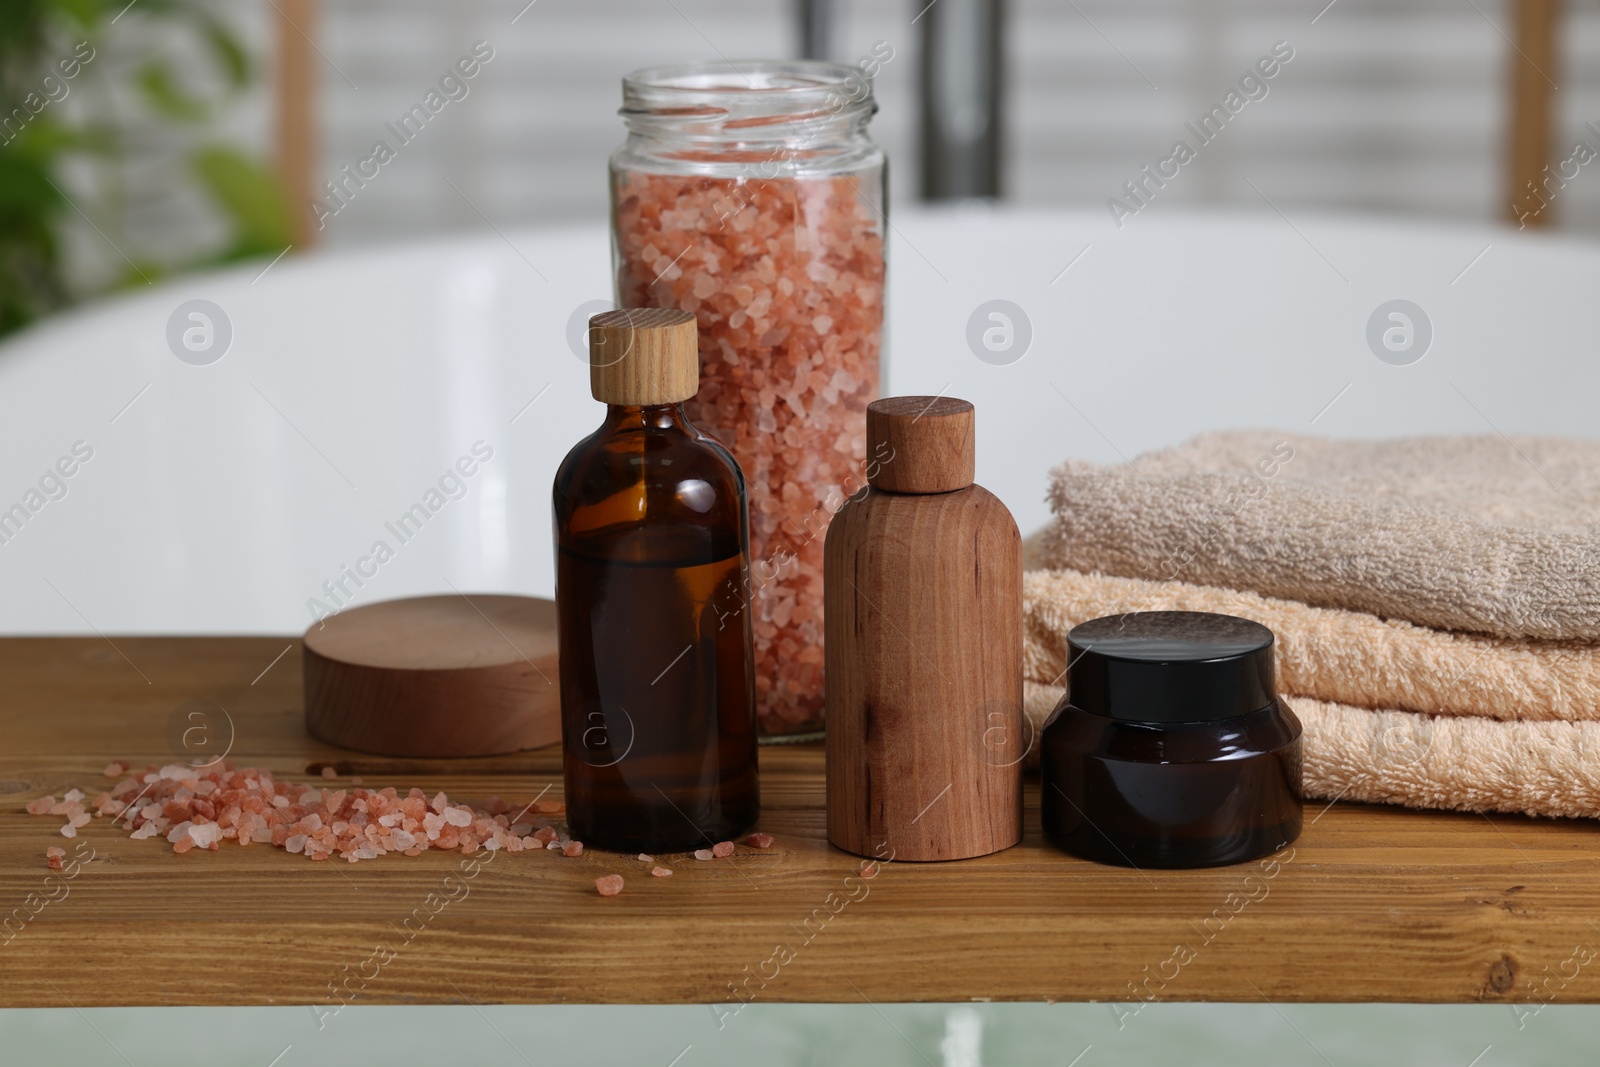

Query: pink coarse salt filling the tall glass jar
[{"left": 614, "top": 171, "right": 883, "bottom": 733}]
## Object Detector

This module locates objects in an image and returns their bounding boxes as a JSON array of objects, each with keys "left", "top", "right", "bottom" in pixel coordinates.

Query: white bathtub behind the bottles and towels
[{"left": 0, "top": 210, "right": 1600, "bottom": 633}]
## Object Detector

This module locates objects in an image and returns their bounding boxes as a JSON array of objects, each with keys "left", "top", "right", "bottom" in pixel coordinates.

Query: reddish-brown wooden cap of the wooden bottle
[{"left": 867, "top": 397, "right": 976, "bottom": 493}]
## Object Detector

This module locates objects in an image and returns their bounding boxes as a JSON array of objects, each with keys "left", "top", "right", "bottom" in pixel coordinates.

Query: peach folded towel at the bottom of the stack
[{"left": 1022, "top": 681, "right": 1600, "bottom": 819}]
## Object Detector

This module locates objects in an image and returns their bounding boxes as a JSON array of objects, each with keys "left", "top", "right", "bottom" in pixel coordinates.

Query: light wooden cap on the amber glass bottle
[{"left": 589, "top": 307, "right": 699, "bottom": 408}]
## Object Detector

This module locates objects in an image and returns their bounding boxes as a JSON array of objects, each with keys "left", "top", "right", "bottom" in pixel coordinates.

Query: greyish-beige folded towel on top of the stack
[{"left": 1042, "top": 430, "right": 1600, "bottom": 640}]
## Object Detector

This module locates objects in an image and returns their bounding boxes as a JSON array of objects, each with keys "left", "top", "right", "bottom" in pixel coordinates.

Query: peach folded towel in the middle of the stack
[{"left": 1022, "top": 571, "right": 1600, "bottom": 720}]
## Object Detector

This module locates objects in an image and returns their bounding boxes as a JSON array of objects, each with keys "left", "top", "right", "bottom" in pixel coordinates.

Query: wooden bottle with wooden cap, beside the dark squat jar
[{"left": 824, "top": 397, "right": 1030, "bottom": 861}]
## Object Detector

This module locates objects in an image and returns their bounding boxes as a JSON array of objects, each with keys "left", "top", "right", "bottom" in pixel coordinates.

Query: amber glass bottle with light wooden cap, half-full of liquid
[{"left": 554, "top": 309, "right": 760, "bottom": 853}]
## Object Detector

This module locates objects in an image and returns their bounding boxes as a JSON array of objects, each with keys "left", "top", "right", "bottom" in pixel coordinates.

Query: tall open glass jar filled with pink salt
[{"left": 611, "top": 61, "right": 886, "bottom": 734}]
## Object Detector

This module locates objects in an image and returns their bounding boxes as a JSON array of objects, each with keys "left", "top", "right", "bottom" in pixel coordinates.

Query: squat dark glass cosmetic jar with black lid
[{"left": 1040, "top": 611, "right": 1301, "bottom": 867}]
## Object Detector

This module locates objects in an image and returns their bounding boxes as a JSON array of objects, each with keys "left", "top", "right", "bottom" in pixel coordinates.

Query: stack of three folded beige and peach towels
[{"left": 1024, "top": 430, "right": 1600, "bottom": 817}]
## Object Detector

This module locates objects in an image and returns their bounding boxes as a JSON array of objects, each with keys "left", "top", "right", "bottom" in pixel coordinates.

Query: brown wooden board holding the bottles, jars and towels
[{"left": 0, "top": 637, "right": 1600, "bottom": 1013}]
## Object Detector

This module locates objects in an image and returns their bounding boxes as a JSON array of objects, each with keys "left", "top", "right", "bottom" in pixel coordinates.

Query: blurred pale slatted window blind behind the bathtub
[{"left": 294, "top": 0, "right": 1600, "bottom": 245}]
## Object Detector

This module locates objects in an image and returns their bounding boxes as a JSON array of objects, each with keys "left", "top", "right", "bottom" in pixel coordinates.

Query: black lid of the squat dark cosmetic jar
[{"left": 1067, "top": 611, "right": 1277, "bottom": 723}]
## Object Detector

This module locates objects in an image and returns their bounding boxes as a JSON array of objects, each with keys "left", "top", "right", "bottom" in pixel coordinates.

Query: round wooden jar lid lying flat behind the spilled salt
[{"left": 304, "top": 593, "right": 562, "bottom": 757}]
